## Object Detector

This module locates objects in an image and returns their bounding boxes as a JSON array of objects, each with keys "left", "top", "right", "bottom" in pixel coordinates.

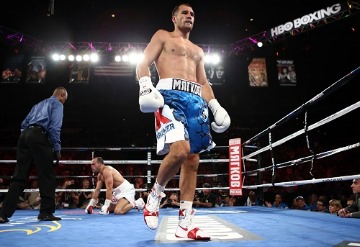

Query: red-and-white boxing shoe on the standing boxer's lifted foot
[{"left": 143, "top": 189, "right": 166, "bottom": 230}]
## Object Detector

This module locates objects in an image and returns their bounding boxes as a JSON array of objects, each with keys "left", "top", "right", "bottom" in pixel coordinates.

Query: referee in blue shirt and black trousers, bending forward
[{"left": 0, "top": 87, "right": 68, "bottom": 223}]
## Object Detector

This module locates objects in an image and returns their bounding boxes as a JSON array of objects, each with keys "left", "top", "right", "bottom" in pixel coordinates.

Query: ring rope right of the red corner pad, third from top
[{"left": 243, "top": 142, "right": 360, "bottom": 175}]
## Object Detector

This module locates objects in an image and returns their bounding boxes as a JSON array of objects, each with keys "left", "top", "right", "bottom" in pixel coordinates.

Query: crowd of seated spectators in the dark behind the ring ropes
[{"left": 0, "top": 140, "right": 359, "bottom": 215}]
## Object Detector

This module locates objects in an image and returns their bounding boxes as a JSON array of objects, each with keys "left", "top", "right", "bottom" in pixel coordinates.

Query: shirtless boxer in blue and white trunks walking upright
[{"left": 136, "top": 4, "right": 230, "bottom": 240}]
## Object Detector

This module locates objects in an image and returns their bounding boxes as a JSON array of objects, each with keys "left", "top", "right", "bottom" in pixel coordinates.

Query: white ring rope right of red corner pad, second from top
[{"left": 243, "top": 101, "right": 360, "bottom": 160}]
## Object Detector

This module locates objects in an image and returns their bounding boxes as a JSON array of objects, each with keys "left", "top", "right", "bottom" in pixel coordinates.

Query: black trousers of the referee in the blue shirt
[{"left": 0, "top": 127, "right": 56, "bottom": 218}]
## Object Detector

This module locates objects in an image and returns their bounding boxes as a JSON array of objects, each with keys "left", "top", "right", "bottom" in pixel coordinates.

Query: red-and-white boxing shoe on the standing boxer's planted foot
[{"left": 175, "top": 209, "right": 211, "bottom": 241}]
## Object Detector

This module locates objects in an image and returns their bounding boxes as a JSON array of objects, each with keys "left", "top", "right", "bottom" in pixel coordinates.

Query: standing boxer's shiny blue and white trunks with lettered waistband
[{"left": 155, "top": 78, "right": 215, "bottom": 155}]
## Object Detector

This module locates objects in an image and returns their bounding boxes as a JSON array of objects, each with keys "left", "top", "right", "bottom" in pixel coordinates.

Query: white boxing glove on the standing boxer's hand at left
[{"left": 139, "top": 76, "right": 164, "bottom": 113}]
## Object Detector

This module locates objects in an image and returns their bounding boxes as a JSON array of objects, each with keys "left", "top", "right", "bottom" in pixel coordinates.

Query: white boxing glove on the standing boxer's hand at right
[{"left": 208, "top": 99, "right": 231, "bottom": 133}]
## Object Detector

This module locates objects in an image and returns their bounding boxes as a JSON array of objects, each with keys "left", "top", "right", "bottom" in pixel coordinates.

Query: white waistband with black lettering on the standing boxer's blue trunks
[{"left": 156, "top": 78, "right": 202, "bottom": 97}]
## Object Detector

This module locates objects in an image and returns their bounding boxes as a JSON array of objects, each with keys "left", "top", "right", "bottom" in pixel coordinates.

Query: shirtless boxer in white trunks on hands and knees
[{"left": 85, "top": 157, "right": 145, "bottom": 214}]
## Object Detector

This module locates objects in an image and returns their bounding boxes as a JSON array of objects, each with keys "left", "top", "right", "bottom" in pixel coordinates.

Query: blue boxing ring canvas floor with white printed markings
[{"left": 0, "top": 207, "right": 360, "bottom": 247}]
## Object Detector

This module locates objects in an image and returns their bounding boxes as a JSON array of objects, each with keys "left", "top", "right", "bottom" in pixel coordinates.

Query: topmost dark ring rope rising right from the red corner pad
[{"left": 243, "top": 66, "right": 360, "bottom": 145}]
